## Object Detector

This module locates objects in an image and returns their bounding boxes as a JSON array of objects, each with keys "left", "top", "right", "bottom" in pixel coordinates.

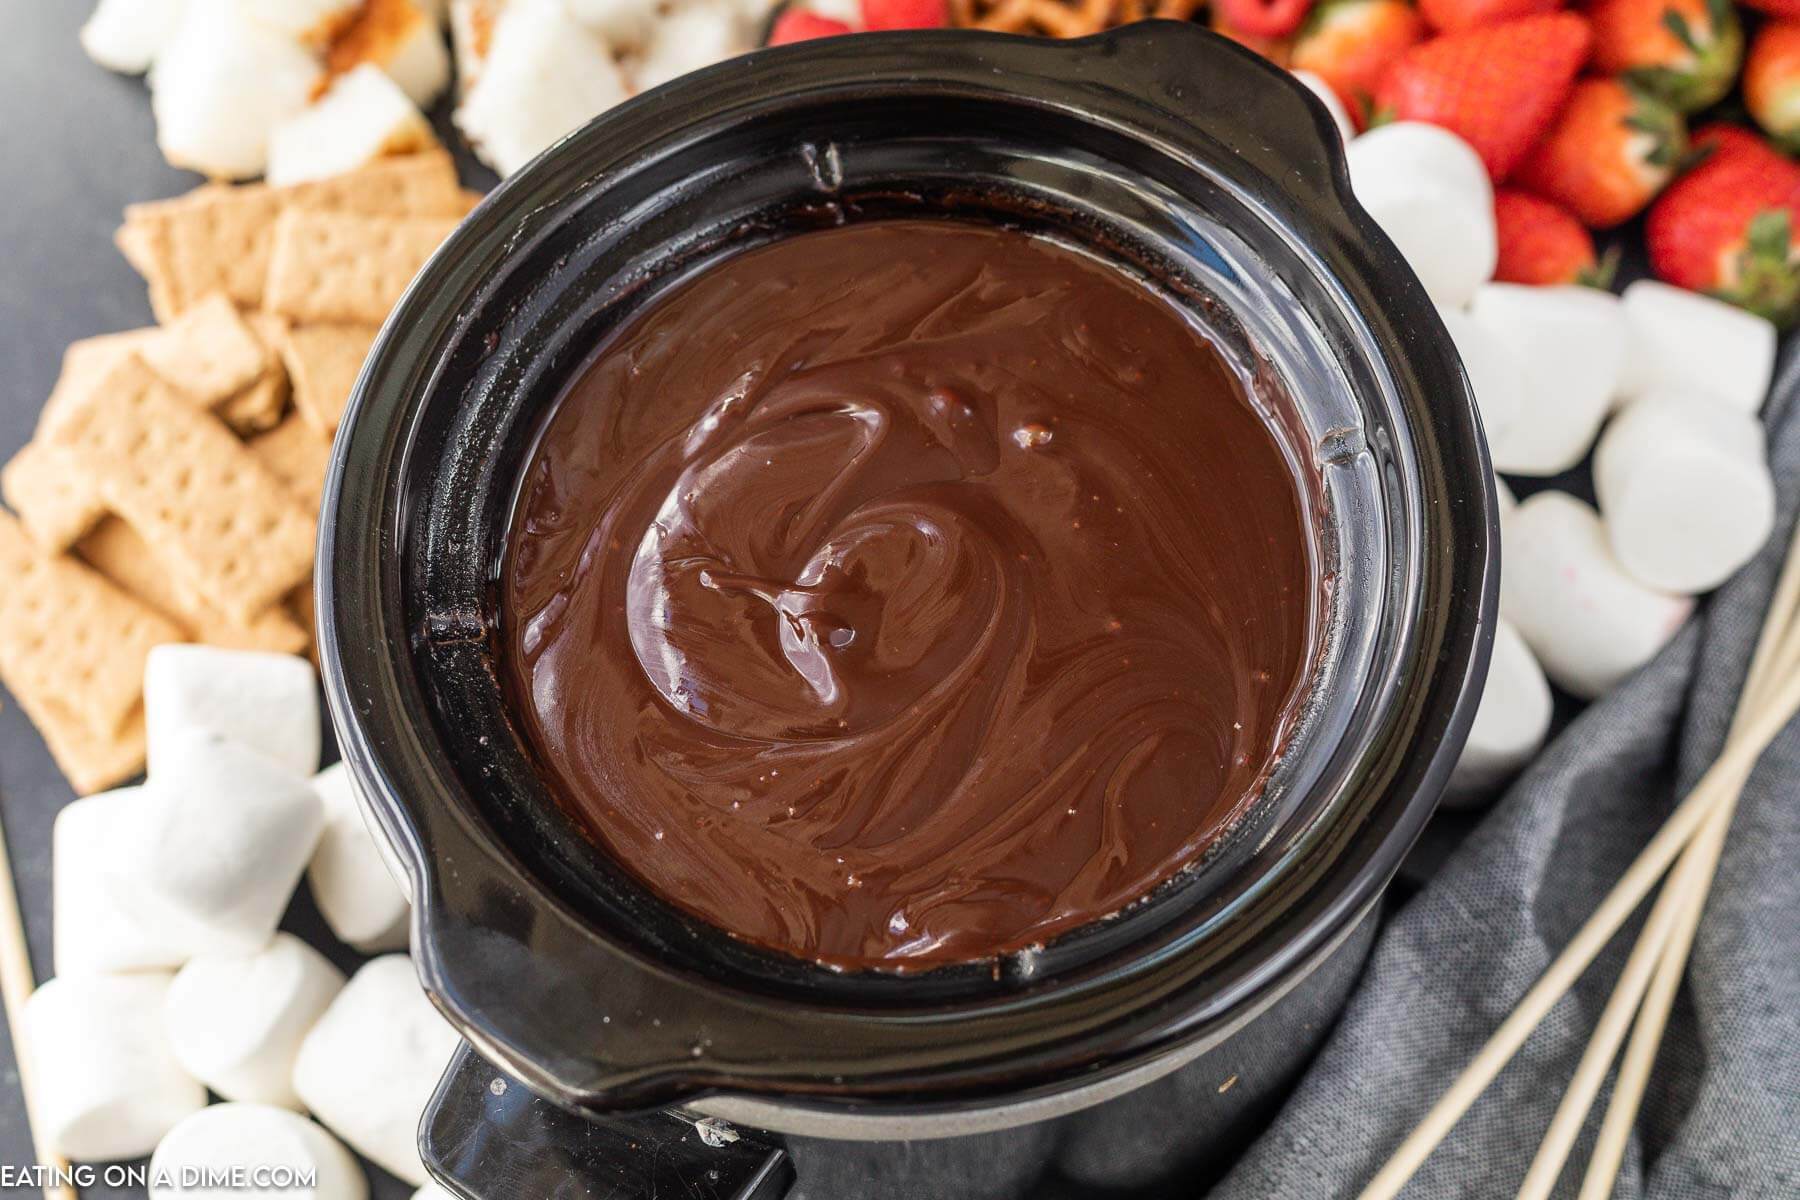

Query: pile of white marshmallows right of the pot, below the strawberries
[{"left": 1348, "top": 122, "right": 1777, "bottom": 793}]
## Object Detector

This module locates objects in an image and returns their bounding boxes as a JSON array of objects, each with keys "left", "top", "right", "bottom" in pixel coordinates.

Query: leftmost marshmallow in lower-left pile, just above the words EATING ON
[{"left": 22, "top": 972, "right": 207, "bottom": 1162}]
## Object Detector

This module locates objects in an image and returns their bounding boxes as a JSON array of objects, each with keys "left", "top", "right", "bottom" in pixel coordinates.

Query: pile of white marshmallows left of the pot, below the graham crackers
[{"left": 23, "top": 646, "right": 457, "bottom": 1200}]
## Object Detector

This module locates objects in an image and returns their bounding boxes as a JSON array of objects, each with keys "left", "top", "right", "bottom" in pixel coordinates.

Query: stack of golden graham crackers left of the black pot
[{"left": 0, "top": 149, "right": 473, "bottom": 793}]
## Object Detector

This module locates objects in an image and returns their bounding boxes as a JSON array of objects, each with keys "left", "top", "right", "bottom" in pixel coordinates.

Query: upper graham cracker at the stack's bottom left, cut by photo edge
[{"left": 0, "top": 513, "right": 182, "bottom": 759}]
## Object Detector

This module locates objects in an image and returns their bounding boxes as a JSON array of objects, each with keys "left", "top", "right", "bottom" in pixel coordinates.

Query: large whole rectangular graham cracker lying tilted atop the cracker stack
[{"left": 56, "top": 356, "right": 315, "bottom": 622}]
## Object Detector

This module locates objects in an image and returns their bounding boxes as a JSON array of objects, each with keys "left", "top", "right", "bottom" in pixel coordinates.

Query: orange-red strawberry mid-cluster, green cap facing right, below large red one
[{"left": 1512, "top": 79, "right": 1687, "bottom": 228}]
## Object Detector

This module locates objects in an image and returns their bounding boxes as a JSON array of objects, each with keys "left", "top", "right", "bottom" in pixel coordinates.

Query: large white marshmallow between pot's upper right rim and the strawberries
[{"left": 1345, "top": 121, "right": 1499, "bottom": 308}]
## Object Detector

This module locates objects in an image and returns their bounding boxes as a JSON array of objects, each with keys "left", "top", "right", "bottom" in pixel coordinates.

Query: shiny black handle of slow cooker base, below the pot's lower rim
[{"left": 419, "top": 1043, "right": 794, "bottom": 1200}]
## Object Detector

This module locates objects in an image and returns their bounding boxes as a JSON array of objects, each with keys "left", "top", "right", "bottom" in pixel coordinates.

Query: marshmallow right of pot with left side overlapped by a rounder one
[{"left": 1469, "top": 282, "right": 1625, "bottom": 475}]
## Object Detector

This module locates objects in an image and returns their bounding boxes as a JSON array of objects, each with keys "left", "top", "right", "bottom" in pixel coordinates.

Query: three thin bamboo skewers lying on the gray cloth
[{"left": 1359, "top": 529, "right": 1800, "bottom": 1200}]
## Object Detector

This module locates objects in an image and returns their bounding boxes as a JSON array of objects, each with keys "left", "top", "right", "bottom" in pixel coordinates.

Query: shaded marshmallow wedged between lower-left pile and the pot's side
[{"left": 306, "top": 763, "right": 410, "bottom": 954}]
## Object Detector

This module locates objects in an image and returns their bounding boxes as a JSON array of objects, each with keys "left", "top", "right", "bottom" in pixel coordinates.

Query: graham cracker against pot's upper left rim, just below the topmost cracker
[{"left": 263, "top": 209, "right": 457, "bottom": 324}]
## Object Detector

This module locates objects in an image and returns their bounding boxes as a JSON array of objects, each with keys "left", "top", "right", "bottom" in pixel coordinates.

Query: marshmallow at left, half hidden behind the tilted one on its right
[{"left": 50, "top": 788, "right": 187, "bottom": 975}]
